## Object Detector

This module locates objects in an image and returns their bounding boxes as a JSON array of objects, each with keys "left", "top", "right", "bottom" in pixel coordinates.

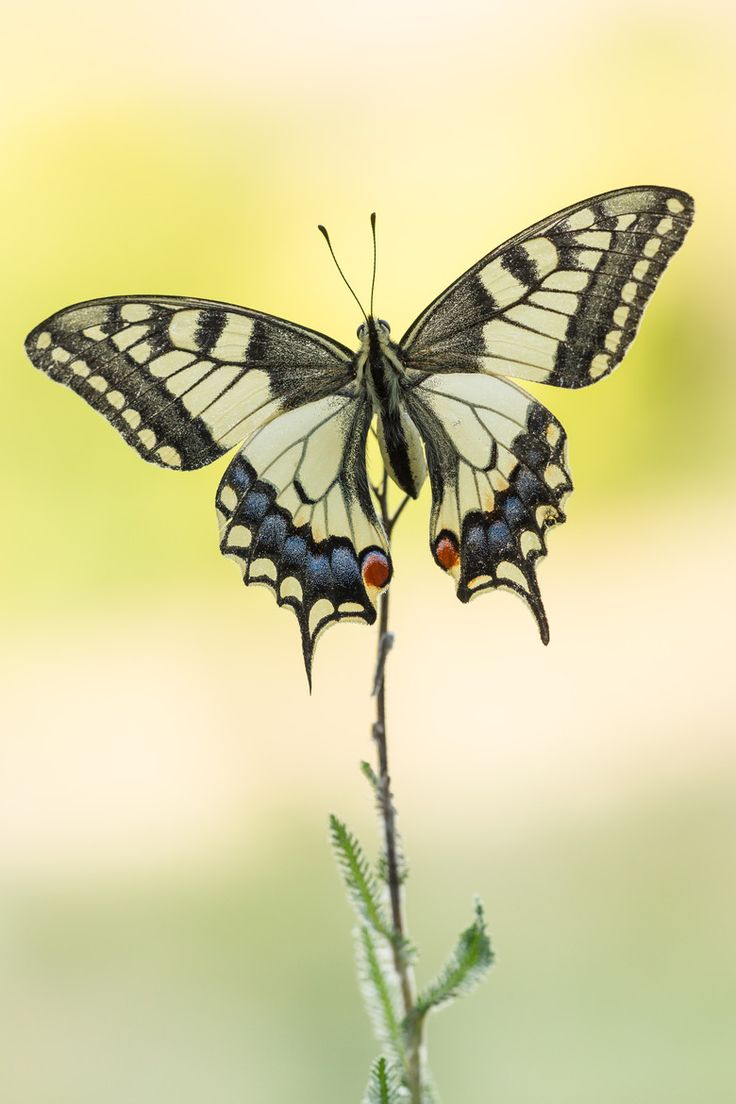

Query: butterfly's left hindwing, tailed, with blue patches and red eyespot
[{"left": 217, "top": 389, "right": 392, "bottom": 684}]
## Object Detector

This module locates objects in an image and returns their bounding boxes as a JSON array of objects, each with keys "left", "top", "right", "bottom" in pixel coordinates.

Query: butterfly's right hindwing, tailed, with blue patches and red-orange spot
[{"left": 407, "top": 373, "right": 573, "bottom": 644}]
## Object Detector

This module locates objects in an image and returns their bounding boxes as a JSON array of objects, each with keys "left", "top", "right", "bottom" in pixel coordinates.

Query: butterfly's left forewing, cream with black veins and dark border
[{"left": 25, "top": 296, "right": 352, "bottom": 469}]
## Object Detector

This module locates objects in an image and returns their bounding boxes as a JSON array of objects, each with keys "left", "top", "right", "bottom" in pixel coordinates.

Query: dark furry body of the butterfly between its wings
[{"left": 355, "top": 316, "right": 427, "bottom": 498}]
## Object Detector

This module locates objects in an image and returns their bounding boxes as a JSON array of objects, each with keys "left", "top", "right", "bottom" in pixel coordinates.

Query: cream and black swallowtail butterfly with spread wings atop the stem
[{"left": 25, "top": 187, "right": 693, "bottom": 677}]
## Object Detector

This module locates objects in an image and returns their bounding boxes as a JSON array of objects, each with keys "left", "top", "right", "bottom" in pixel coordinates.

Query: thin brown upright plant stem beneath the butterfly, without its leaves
[{"left": 372, "top": 475, "right": 423, "bottom": 1104}]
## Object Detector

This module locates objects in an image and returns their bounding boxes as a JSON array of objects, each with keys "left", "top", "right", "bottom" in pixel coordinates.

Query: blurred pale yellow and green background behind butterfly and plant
[{"left": 0, "top": 0, "right": 736, "bottom": 1104}]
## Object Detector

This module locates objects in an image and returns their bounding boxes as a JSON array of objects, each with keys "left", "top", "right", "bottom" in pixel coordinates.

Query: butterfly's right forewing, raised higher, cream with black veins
[{"left": 401, "top": 187, "right": 694, "bottom": 388}]
